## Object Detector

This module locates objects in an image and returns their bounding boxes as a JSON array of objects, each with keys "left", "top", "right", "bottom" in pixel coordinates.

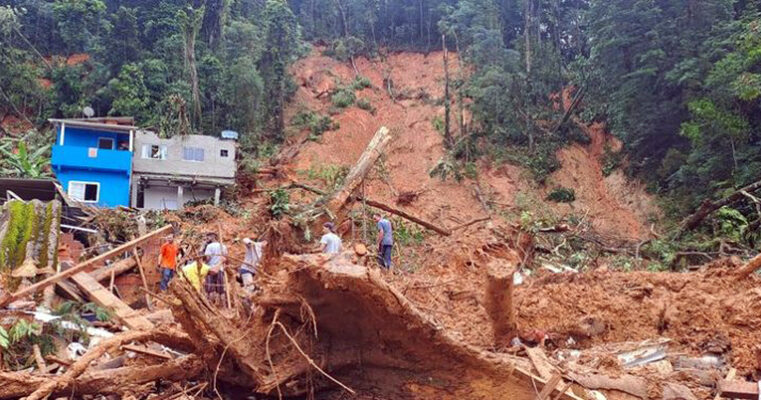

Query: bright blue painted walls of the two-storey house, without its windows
[{"left": 51, "top": 126, "right": 132, "bottom": 207}]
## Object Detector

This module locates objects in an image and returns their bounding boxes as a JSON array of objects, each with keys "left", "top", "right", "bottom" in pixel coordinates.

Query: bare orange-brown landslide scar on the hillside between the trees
[{"left": 287, "top": 49, "right": 656, "bottom": 240}]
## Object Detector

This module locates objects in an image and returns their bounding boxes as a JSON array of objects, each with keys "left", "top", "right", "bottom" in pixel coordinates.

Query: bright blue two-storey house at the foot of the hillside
[{"left": 50, "top": 118, "right": 138, "bottom": 207}]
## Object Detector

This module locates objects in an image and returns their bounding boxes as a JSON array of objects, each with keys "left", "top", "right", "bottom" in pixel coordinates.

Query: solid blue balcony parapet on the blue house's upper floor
[{"left": 50, "top": 145, "right": 132, "bottom": 174}]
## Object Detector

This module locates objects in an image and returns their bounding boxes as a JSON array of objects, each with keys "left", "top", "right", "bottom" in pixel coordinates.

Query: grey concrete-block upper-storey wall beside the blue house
[{"left": 132, "top": 131, "right": 236, "bottom": 179}]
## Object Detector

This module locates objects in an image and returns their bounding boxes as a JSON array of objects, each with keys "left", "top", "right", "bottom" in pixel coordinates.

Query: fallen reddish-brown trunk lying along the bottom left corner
[{"left": 0, "top": 355, "right": 204, "bottom": 399}]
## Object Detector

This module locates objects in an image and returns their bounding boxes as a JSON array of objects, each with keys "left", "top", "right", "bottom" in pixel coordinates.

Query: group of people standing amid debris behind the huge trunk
[{"left": 152, "top": 214, "right": 394, "bottom": 305}]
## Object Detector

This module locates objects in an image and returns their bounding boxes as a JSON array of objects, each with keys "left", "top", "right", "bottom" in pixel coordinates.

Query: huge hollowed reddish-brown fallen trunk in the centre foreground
[{"left": 171, "top": 255, "right": 576, "bottom": 400}]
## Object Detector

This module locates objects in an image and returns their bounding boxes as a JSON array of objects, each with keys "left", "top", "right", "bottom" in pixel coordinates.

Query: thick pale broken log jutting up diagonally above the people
[{"left": 327, "top": 126, "right": 392, "bottom": 215}]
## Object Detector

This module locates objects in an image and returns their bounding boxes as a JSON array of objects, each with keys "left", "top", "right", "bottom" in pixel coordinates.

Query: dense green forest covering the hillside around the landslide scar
[{"left": 0, "top": 0, "right": 761, "bottom": 245}]
